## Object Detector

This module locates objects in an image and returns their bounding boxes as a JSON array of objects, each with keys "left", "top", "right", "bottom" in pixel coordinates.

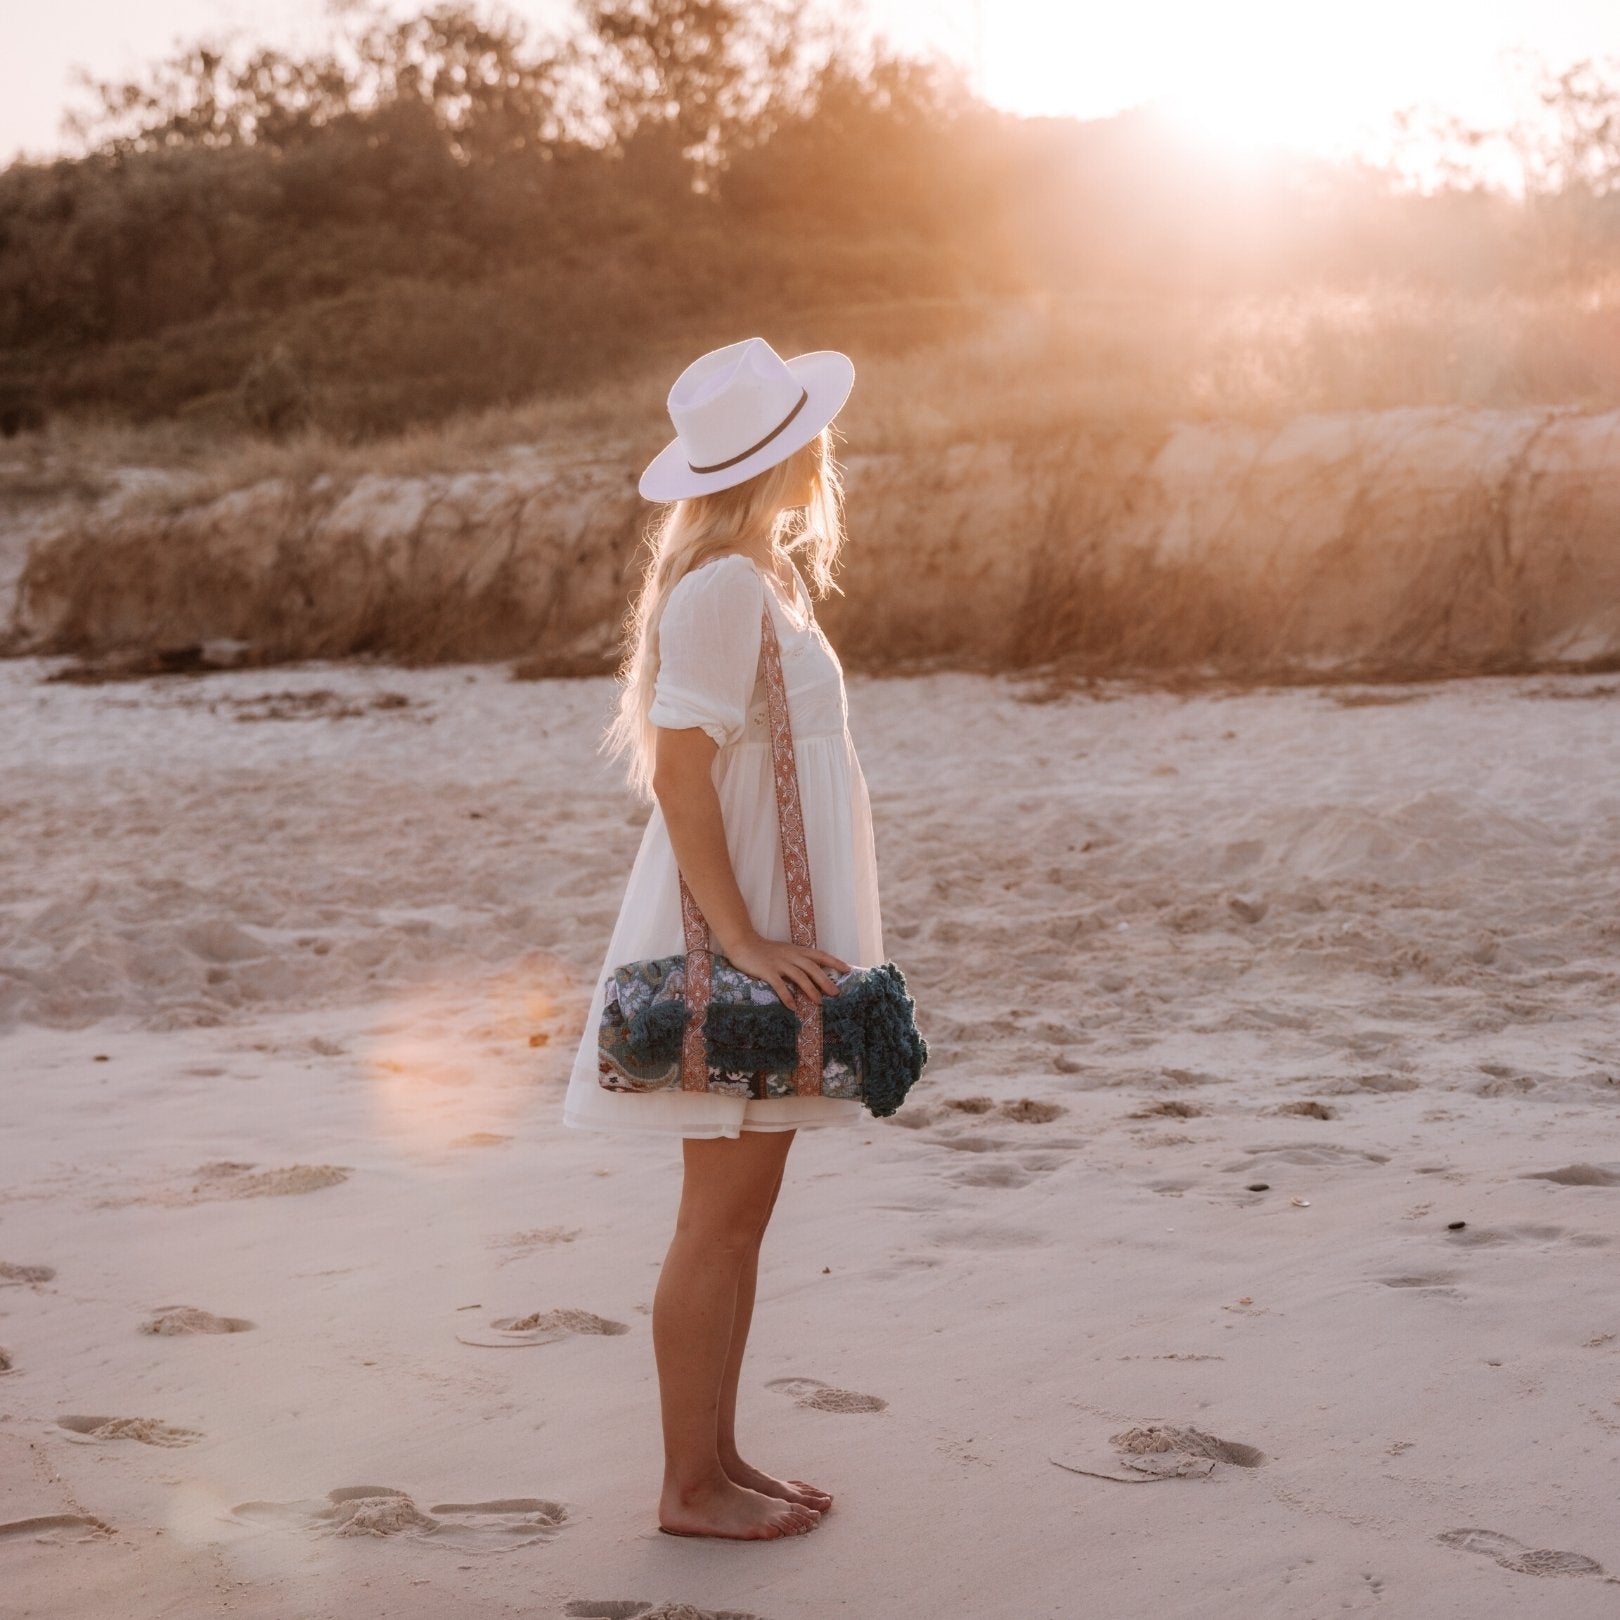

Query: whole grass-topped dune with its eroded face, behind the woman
[{"left": 9, "top": 284, "right": 1620, "bottom": 683}]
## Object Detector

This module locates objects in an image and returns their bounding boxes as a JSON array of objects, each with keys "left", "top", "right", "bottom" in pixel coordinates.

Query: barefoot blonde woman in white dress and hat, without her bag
[{"left": 562, "top": 339, "right": 883, "bottom": 1539}]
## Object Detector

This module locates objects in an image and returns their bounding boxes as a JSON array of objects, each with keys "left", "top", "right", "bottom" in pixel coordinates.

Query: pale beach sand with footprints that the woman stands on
[{"left": 0, "top": 661, "right": 1620, "bottom": 1620}]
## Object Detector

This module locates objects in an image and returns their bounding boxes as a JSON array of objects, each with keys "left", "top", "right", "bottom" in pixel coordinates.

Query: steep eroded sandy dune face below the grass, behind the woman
[{"left": 11, "top": 407, "right": 1620, "bottom": 679}]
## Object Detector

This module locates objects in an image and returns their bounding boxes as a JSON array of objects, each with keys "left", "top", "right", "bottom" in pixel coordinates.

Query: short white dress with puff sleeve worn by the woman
[{"left": 562, "top": 554, "right": 885, "bottom": 1137}]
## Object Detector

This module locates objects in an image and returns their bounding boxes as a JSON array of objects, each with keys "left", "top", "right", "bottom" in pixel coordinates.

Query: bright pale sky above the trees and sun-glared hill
[{"left": 0, "top": 0, "right": 1620, "bottom": 164}]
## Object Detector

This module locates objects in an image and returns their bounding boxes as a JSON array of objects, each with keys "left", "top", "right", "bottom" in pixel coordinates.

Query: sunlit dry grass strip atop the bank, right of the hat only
[{"left": 844, "top": 279, "right": 1620, "bottom": 452}]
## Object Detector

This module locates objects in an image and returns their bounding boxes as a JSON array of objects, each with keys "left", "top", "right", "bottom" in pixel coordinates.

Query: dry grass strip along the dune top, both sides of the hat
[{"left": 19, "top": 277, "right": 1620, "bottom": 496}]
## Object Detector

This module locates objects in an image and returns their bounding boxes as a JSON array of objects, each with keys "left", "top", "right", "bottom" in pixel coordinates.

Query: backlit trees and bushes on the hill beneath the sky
[{"left": 0, "top": 0, "right": 1620, "bottom": 444}]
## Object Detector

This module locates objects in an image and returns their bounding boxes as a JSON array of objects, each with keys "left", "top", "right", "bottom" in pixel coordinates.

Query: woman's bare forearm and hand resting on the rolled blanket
[{"left": 653, "top": 726, "right": 851, "bottom": 1006}]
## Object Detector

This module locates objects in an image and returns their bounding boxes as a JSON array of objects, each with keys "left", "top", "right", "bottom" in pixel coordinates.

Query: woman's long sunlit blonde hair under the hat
[{"left": 601, "top": 426, "right": 844, "bottom": 804}]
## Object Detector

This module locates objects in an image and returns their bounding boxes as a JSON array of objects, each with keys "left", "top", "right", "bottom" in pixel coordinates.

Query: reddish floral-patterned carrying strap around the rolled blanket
[{"left": 680, "top": 589, "right": 821, "bottom": 1097}]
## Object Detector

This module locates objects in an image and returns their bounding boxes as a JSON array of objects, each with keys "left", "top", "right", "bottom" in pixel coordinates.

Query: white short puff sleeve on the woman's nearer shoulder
[{"left": 646, "top": 556, "right": 765, "bottom": 748}]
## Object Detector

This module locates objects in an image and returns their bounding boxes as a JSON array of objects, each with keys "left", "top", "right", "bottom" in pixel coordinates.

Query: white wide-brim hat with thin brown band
[{"left": 640, "top": 337, "right": 855, "bottom": 501}]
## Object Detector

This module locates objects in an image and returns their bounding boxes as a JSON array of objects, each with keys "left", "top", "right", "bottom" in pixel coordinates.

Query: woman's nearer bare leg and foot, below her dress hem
[{"left": 653, "top": 1131, "right": 820, "bottom": 1541}]
